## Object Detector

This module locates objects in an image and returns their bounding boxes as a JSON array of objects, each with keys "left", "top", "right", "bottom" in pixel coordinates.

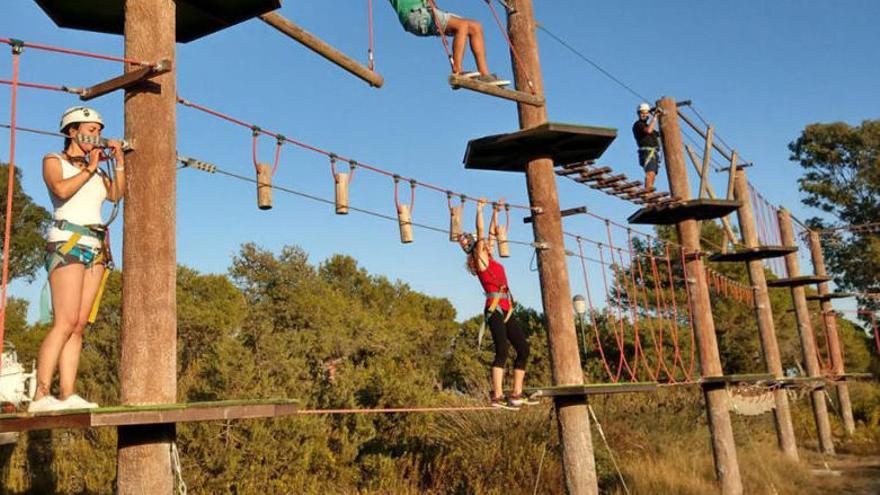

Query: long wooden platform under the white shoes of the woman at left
[{"left": 0, "top": 399, "right": 299, "bottom": 433}]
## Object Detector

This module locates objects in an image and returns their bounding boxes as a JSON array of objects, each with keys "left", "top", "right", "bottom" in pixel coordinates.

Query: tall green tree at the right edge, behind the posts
[{"left": 788, "top": 120, "right": 880, "bottom": 309}]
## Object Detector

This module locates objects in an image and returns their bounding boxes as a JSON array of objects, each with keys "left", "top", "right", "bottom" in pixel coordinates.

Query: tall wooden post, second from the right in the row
[{"left": 778, "top": 208, "right": 834, "bottom": 454}]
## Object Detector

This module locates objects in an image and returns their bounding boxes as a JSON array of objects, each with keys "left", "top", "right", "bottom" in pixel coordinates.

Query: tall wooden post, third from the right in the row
[{"left": 733, "top": 168, "right": 798, "bottom": 460}]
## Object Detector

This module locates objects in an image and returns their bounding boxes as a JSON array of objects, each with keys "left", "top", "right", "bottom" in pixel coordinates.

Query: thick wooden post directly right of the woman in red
[{"left": 507, "top": 0, "right": 599, "bottom": 495}]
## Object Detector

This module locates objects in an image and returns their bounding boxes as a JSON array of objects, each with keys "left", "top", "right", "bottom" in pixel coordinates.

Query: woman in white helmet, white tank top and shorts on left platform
[{"left": 28, "top": 107, "right": 125, "bottom": 412}]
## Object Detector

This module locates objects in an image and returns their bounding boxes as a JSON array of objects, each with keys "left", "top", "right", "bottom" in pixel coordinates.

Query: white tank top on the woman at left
[{"left": 47, "top": 153, "right": 107, "bottom": 248}]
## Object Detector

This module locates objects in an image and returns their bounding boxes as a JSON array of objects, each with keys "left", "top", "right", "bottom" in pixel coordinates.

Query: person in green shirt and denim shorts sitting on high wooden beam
[{"left": 389, "top": 0, "right": 510, "bottom": 86}]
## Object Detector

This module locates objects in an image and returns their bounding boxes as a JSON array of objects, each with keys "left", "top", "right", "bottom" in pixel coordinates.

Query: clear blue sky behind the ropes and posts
[{"left": 0, "top": 0, "right": 880, "bottom": 324}]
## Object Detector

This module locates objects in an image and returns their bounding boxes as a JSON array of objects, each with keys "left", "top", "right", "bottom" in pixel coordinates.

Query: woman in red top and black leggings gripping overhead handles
[{"left": 459, "top": 199, "right": 537, "bottom": 409}]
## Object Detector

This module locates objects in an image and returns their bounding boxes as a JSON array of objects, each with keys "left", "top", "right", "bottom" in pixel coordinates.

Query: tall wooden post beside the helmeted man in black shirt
[{"left": 657, "top": 97, "right": 743, "bottom": 495}]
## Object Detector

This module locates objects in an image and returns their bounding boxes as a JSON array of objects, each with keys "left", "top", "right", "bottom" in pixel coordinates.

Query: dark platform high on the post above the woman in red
[{"left": 464, "top": 122, "right": 617, "bottom": 172}]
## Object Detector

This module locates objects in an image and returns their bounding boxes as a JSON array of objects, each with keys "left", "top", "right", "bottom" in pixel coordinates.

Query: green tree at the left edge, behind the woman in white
[{"left": 0, "top": 163, "right": 51, "bottom": 280}]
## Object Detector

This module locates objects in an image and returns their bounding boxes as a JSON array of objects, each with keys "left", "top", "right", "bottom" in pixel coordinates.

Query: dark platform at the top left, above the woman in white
[{"left": 37, "top": 0, "right": 281, "bottom": 43}]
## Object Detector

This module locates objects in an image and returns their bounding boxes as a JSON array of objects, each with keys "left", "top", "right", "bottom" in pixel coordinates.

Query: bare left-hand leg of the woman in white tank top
[{"left": 34, "top": 263, "right": 85, "bottom": 401}]
